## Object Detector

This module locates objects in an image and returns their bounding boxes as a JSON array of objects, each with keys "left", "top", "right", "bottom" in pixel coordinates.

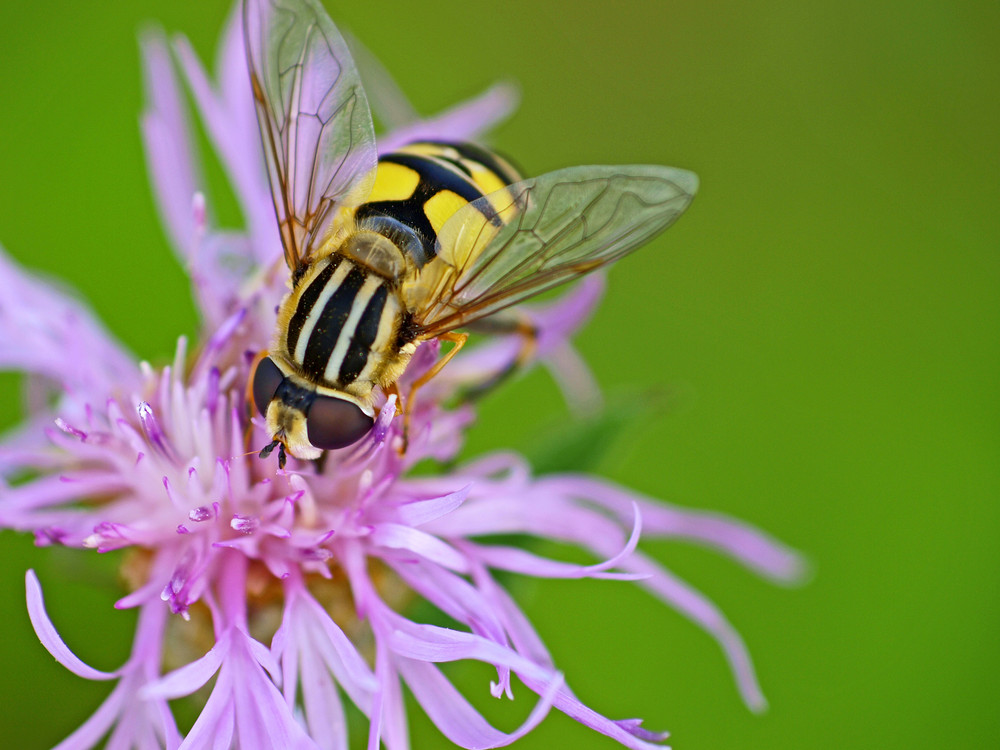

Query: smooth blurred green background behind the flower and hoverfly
[{"left": 0, "top": 0, "right": 1000, "bottom": 750}]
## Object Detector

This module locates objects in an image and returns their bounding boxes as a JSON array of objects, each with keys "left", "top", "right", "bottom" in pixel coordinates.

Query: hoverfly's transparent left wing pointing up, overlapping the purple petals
[{"left": 243, "top": 0, "right": 378, "bottom": 270}]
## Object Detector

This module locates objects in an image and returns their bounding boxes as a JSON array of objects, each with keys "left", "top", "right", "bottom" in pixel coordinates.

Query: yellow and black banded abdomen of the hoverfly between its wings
[{"left": 354, "top": 142, "right": 521, "bottom": 268}]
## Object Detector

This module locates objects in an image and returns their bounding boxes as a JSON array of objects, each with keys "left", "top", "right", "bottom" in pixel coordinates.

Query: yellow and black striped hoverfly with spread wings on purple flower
[{"left": 243, "top": 0, "right": 698, "bottom": 466}]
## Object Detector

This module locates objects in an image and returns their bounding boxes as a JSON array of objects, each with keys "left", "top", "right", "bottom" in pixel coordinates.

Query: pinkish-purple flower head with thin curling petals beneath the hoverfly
[{"left": 0, "top": 2, "right": 799, "bottom": 749}]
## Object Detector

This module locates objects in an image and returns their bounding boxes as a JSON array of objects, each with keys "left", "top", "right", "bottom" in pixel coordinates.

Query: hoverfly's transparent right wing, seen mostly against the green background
[{"left": 403, "top": 166, "right": 698, "bottom": 338}]
